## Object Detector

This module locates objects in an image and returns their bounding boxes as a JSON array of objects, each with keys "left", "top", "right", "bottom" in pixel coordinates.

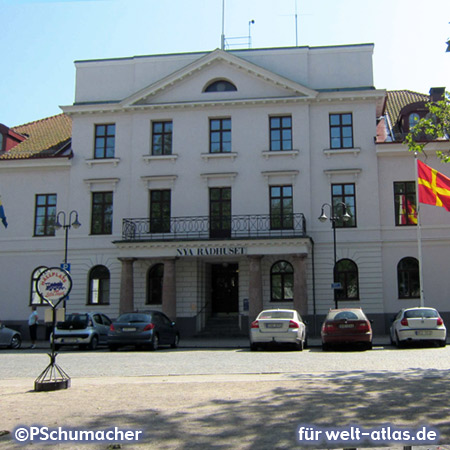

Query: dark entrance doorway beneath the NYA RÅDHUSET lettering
[{"left": 211, "top": 264, "right": 239, "bottom": 315}]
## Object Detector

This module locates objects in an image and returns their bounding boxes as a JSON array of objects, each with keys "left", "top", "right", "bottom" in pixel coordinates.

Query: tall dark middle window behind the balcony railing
[{"left": 209, "top": 187, "right": 231, "bottom": 238}]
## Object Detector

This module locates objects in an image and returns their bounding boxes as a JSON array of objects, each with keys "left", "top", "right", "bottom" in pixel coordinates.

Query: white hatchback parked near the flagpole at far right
[{"left": 390, "top": 307, "right": 447, "bottom": 347}]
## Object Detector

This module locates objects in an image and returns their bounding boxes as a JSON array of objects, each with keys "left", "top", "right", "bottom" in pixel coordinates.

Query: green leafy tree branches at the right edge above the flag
[{"left": 405, "top": 92, "right": 450, "bottom": 163}]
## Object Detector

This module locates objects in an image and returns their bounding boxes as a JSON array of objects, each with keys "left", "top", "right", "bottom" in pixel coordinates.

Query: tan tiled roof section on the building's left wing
[{"left": 0, "top": 114, "right": 72, "bottom": 160}]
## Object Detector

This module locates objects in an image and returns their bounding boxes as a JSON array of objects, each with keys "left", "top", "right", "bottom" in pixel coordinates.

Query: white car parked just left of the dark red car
[{"left": 250, "top": 309, "right": 307, "bottom": 351}]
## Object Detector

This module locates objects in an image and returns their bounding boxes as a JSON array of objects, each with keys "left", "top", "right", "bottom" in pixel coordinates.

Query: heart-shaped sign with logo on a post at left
[{"left": 36, "top": 267, "right": 72, "bottom": 307}]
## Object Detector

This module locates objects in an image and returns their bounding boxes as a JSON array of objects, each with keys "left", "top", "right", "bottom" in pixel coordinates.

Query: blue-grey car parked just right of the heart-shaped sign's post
[{"left": 50, "top": 312, "right": 112, "bottom": 350}]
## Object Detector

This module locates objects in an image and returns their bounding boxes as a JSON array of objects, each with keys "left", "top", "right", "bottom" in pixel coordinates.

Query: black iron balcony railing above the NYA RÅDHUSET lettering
[{"left": 122, "top": 213, "right": 306, "bottom": 241}]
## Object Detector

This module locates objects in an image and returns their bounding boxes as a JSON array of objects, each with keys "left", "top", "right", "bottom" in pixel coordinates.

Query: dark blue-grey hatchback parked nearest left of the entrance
[{"left": 108, "top": 311, "right": 180, "bottom": 351}]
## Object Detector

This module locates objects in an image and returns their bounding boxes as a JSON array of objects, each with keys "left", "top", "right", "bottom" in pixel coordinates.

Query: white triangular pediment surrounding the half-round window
[{"left": 121, "top": 50, "right": 317, "bottom": 108}]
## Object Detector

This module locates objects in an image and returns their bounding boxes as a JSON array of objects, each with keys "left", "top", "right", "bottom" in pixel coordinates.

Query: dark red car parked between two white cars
[{"left": 321, "top": 308, "right": 373, "bottom": 350}]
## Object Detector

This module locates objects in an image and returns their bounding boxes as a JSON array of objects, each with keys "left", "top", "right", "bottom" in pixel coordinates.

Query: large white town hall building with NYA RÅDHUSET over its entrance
[{"left": 0, "top": 44, "right": 450, "bottom": 342}]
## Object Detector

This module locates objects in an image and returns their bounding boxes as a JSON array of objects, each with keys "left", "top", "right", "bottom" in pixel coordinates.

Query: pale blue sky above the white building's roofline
[{"left": 0, "top": 0, "right": 450, "bottom": 126}]
